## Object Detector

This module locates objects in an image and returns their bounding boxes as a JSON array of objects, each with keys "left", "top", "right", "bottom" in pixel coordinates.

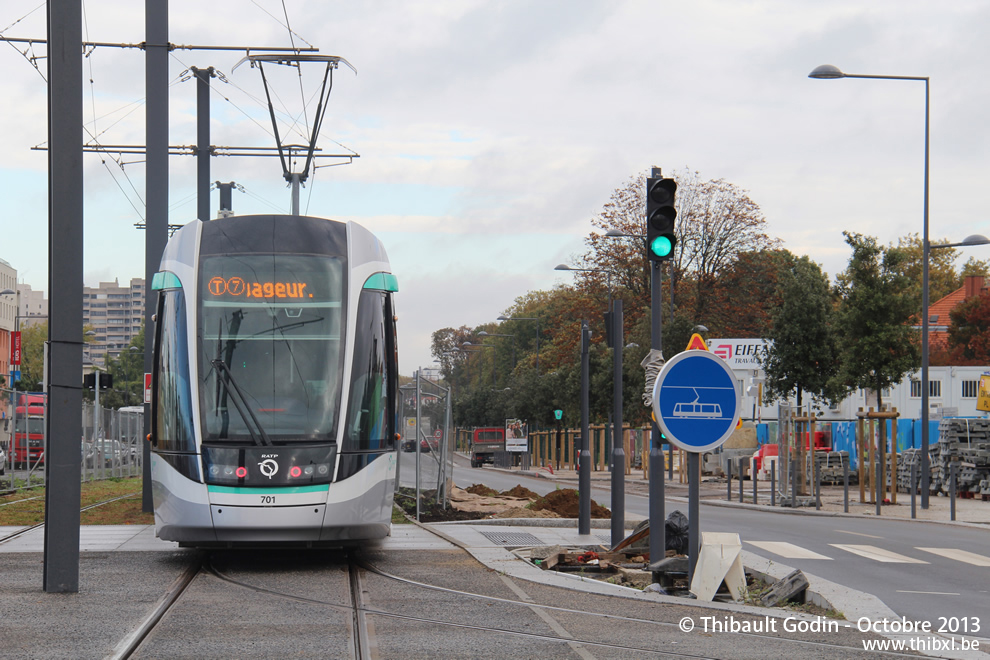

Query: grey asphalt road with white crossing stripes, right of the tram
[{"left": 454, "top": 457, "right": 990, "bottom": 638}]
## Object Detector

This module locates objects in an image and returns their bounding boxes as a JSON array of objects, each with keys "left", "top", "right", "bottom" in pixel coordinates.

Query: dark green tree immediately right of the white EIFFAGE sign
[{"left": 761, "top": 256, "right": 842, "bottom": 407}]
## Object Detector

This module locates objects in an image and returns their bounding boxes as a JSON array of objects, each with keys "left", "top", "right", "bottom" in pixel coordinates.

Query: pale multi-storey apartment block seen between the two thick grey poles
[{"left": 83, "top": 277, "right": 145, "bottom": 367}]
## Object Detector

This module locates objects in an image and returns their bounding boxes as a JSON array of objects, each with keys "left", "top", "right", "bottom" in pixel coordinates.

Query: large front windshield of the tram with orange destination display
[{"left": 198, "top": 254, "right": 346, "bottom": 445}]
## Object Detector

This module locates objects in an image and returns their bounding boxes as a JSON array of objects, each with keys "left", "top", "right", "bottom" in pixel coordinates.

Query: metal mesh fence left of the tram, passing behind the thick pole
[{"left": 0, "top": 390, "right": 144, "bottom": 490}]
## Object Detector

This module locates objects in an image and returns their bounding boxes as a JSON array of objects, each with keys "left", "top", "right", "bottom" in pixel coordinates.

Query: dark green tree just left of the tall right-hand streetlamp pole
[{"left": 836, "top": 232, "right": 921, "bottom": 407}]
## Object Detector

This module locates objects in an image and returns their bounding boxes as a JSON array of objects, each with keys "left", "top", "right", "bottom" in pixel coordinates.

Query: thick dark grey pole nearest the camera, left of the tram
[{"left": 43, "top": 0, "right": 83, "bottom": 593}]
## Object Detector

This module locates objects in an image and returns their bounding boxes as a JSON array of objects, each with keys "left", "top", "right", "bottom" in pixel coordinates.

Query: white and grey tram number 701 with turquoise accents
[{"left": 149, "top": 215, "right": 398, "bottom": 547}]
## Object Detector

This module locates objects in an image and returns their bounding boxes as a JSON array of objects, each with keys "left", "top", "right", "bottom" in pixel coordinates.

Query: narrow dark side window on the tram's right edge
[{"left": 341, "top": 289, "right": 398, "bottom": 452}]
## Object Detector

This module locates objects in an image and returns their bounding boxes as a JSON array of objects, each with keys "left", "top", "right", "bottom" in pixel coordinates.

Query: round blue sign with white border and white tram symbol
[{"left": 653, "top": 350, "right": 739, "bottom": 452}]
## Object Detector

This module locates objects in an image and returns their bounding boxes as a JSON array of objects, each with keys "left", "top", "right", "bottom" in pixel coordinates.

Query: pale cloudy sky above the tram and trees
[{"left": 0, "top": 0, "right": 990, "bottom": 374}]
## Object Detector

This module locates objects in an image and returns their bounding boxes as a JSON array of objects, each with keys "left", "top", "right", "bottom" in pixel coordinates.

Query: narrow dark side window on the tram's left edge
[{"left": 154, "top": 289, "right": 196, "bottom": 452}]
